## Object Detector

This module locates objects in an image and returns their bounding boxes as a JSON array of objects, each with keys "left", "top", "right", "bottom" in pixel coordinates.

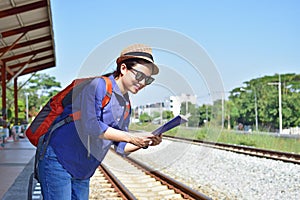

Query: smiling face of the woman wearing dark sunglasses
[{"left": 121, "top": 63, "right": 152, "bottom": 94}]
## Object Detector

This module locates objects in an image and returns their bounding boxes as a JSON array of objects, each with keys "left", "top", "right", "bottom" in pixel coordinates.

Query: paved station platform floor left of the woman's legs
[{"left": 0, "top": 139, "right": 35, "bottom": 200}]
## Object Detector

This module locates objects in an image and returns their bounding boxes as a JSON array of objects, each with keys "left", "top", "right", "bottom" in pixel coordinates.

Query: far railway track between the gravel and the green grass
[{"left": 164, "top": 135, "right": 300, "bottom": 164}]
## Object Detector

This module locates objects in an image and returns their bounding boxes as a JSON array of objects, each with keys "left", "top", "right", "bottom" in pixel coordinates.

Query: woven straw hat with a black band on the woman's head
[{"left": 116, "top": 44, "right": 159, "bottom": 75}]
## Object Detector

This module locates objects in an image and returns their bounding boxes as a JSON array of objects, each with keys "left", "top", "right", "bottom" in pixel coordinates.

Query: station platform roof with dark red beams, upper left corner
[{"left": 0, "top": 0, "right": 56, "bottom": 81}]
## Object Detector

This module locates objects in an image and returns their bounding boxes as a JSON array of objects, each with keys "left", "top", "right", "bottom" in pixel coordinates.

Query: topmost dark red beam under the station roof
[{"left": 0, "top": 0, "right": 47, "bottom": 18}]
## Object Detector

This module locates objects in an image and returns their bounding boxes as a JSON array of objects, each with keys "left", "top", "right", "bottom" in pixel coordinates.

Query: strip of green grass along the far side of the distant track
[{"left": 130, "top": 124, "right": 300, "bottom": 154}]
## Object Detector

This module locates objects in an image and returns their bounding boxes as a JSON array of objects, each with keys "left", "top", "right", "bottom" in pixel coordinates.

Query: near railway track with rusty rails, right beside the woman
[{"left": 90, "top": 149, "right": 211, "bottom": 200}]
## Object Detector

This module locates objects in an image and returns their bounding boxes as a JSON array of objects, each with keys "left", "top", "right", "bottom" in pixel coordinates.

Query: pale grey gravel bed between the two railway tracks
[{"left": 130, "top": 140, "right": 300, "bottom": 200}]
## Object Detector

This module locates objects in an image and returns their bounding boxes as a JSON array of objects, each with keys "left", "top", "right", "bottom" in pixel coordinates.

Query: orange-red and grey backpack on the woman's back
[{"left": 25, "top": 76, "right": 112, "bottom": 146}]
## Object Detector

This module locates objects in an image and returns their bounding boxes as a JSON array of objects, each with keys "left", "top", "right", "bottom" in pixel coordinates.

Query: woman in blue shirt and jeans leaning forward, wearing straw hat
[{"left": 38, "top": 44, "right": 161, "bottom": 200}]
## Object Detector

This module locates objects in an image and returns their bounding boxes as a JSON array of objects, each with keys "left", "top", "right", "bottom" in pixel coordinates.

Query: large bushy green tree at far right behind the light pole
[{"left": 229, "top": 74, "right": 300, "bottom": 131}]
